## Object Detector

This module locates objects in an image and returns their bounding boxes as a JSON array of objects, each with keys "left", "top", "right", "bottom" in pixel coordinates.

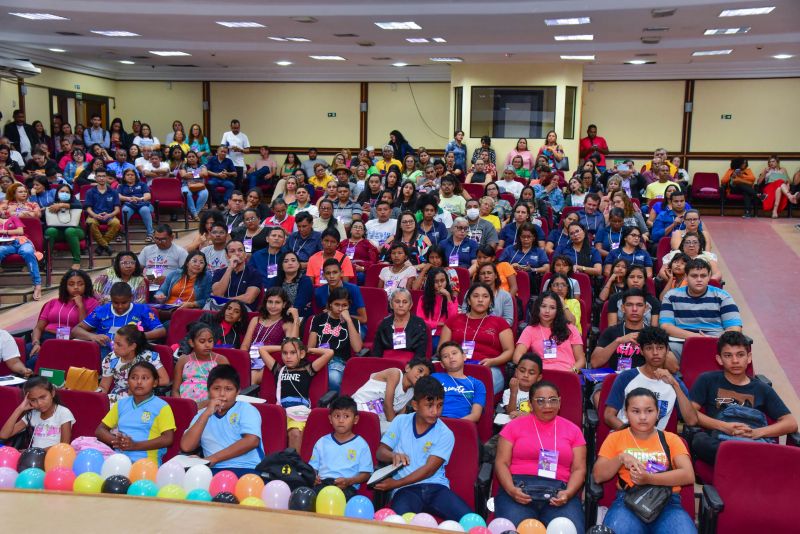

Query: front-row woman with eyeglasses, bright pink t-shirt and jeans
[{"left": 494, "top": 380, "right": 586, "bottom": 532}]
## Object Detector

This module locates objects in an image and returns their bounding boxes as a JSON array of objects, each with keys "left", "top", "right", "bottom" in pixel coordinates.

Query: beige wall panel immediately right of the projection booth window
[{"left": 580, "top": 81, "right": 684, "bottom": 152}]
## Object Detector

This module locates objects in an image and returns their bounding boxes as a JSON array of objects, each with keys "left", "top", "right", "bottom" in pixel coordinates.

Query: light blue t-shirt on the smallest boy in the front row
[{"left": 308, "top": 433, "right": 374, "bottom": 489}]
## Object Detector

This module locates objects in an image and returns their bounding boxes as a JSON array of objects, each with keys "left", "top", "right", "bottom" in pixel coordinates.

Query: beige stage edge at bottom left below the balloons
[{"left": 0, "top": 490, "right": 431, "bottom": 534}]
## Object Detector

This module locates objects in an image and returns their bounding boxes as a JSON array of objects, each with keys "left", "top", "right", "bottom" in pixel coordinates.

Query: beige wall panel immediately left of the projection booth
[{"left": 368, "top": 82, "right": 452, "bottom": 150}]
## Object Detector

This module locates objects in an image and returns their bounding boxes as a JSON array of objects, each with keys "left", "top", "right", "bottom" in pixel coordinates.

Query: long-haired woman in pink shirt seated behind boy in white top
[{"left": 514, "top": 291, "right": 586, "bottom": 373}]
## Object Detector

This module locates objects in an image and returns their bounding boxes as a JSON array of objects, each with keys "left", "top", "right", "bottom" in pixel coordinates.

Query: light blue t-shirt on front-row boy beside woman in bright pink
[{"left": 381, "top": 414, "right": 456, "bottom": 488}]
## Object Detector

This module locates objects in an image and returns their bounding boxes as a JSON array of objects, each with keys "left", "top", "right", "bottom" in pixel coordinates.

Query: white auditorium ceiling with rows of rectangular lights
[{"left": 0, "top": 0, "right": 800, "bottom": 81}]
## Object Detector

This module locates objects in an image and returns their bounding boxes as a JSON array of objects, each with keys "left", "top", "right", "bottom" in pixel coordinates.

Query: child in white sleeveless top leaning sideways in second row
[{"left": 353, "top": 358, "right": 433, "bottom": 434}]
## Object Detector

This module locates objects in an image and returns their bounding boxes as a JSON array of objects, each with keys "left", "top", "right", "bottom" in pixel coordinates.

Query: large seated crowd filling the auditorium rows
[{"left": 0, "top": 115, "right": 797, "bottom": 532}]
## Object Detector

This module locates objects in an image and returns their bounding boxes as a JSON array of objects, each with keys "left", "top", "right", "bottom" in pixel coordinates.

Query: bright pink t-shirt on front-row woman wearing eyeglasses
[{"left": 500, "top": 415, "right": 586, "bottom": 482}]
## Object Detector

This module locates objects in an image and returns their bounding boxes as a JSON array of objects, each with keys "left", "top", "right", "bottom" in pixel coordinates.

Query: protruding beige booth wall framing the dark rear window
[{"left": 448, "top": 63, "right": 583, "bottom": 168}]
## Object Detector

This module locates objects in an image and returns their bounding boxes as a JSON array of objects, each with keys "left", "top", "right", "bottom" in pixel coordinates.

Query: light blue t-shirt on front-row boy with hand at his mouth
[{"left": 189, "top": 401, "right": 264, "bottom": 469}]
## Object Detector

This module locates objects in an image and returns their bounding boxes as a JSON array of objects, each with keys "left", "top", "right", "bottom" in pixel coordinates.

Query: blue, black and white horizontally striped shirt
[{"left": 658, "top": 286, "right": 742, "bottom": 336}]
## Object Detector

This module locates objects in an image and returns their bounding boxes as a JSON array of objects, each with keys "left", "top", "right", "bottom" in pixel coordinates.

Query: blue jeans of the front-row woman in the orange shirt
[{"left": 603, "top": 491, "right": 697, "bottom": 534}]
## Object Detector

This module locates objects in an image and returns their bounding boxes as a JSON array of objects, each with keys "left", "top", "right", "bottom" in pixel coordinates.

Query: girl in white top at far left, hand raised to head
[{"left": 0, "top": 376, "right": 75, "bottom": 449}]
